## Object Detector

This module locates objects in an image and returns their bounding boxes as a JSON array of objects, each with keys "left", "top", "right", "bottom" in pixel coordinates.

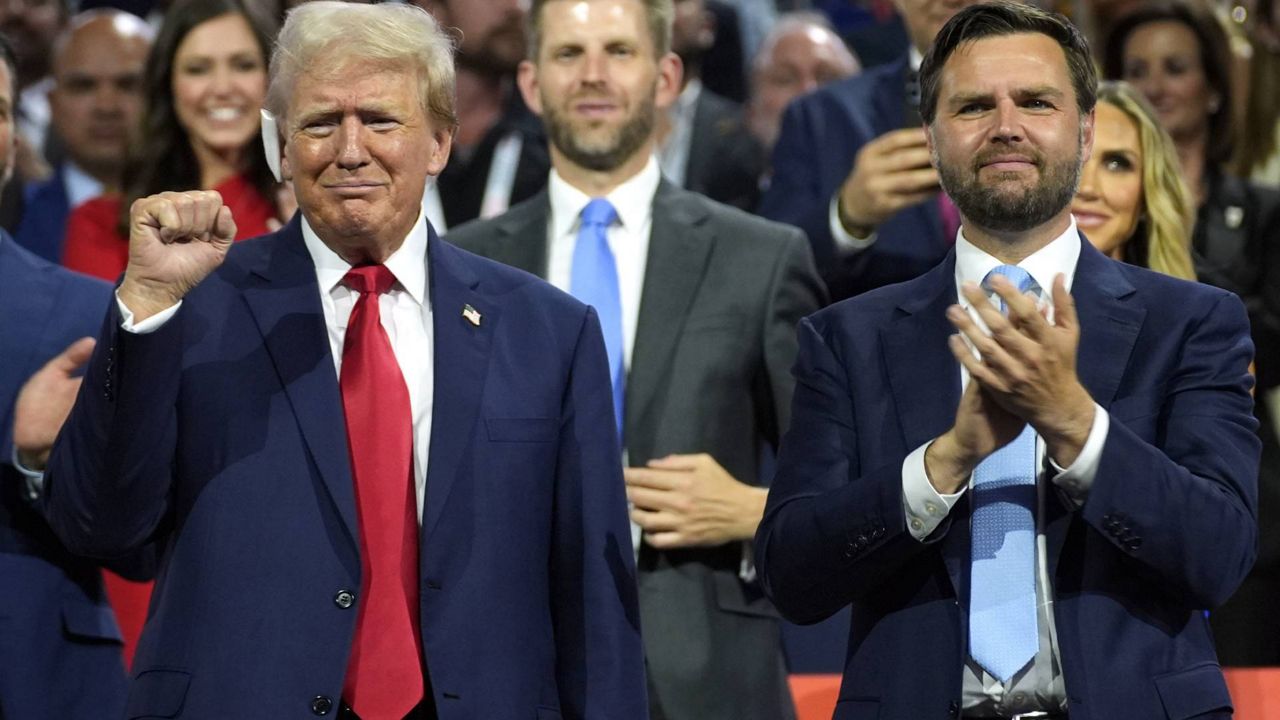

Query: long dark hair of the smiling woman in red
[{"left": 118, "top": 0, "right": 275, "bottom": 234}]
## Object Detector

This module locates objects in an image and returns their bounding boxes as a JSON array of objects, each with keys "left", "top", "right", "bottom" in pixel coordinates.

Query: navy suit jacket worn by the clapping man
[{"left": 756, "top": 238, "right": 1260, "bottom": 720}]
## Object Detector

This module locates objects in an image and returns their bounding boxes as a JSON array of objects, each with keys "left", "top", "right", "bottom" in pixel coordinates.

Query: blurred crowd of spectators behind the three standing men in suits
[{"left": 0, "top": 0, "right": 1280, "bottom": 665}]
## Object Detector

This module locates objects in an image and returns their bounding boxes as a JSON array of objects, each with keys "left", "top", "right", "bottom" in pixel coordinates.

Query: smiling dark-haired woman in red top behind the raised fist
[{"left": 63, "top": 0, "right": 280, "bottom": 281}]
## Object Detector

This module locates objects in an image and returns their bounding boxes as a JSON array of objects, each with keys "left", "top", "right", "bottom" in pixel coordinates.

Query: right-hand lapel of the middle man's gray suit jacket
[{"left": 623, "top": 181, "right": 716, "bottom": 461}]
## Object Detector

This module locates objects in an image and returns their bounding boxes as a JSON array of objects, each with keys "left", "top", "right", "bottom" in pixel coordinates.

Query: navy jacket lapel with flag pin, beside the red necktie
[{"left": 422, "top": 226, "right": 494, "bottom": 538}]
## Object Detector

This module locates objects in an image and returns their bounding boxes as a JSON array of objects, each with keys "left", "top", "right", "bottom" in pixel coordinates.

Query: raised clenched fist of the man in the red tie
[{"left": 120, "top": 191, "right": 236, "bottom": 322}]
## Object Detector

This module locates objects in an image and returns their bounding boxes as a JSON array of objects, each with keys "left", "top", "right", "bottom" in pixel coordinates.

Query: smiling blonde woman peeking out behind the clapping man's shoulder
[{"left": 1071, "top": 82, "right": 1196, "bottom": 279}]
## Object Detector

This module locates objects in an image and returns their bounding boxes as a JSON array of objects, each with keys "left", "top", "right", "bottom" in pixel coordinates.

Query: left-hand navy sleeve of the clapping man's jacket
[{"left": 755, "top": 318, "right": 950, "bottom": 623}]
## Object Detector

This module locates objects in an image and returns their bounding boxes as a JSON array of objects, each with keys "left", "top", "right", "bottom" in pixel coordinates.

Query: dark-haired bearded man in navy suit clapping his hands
[{"left": 756, "top": 3, "right": 1260, "bottom": 720}]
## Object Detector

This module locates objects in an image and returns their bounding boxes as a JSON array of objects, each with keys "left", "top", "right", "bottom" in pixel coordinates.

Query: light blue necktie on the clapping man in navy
[{"left": 969, "top": 265, "right": 1039, "bottom": 683}]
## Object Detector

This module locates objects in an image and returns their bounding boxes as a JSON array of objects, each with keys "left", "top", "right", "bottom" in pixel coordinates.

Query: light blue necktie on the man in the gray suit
[{"left": 568, "top": 197, "right": 626, "bottom": 438}]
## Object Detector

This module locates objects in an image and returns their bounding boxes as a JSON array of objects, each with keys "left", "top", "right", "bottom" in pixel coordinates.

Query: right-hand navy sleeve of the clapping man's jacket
[{"left": 1083, "top": 288, "right": 1261, "bottom": 607}]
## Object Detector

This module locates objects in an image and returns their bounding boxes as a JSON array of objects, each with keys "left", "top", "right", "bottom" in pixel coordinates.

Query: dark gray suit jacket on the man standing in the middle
[{"left": 447, "top": 181, "right": 826, "bottom": 720}]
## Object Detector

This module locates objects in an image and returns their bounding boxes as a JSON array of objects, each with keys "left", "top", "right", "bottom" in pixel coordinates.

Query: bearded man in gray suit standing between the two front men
[{"left": 448, "top": 0, "right": 826, "bottom": 720}]
